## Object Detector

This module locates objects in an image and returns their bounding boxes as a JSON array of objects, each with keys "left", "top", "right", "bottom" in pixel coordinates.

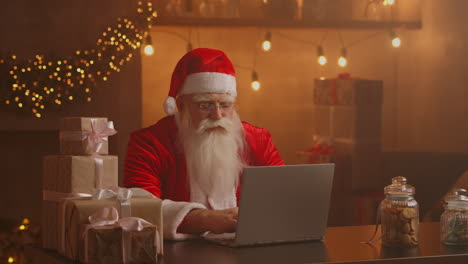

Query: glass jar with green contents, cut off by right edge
[{"left": 440, "top": 189, "right": 468, "bottom": 246}]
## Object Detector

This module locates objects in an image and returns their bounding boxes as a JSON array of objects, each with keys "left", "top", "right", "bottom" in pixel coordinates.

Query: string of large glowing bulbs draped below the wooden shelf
[{"left": 144, "top": 0, "right": 402, "bottom": 91}]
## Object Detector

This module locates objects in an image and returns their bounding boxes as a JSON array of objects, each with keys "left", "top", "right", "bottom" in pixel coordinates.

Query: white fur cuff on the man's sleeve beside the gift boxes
[{"left": 162, "top": 199, "right": 206, "bottom": 240}]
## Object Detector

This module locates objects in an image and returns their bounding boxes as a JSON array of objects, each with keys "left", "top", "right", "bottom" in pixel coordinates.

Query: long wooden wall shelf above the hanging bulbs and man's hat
[{"left": 155, "top": 16, "right": 422, "bottom": 29}]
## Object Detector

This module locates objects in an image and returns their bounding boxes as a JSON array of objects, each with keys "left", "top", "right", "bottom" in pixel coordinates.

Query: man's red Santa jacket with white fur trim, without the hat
[{"left": 124, "top": 116, "right": 284, "bottom": 239}]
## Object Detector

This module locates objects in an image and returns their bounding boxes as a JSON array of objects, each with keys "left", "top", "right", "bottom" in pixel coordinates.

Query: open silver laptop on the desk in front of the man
[{"left": 205, "top": 164, "right": 335, "bottom": 247}]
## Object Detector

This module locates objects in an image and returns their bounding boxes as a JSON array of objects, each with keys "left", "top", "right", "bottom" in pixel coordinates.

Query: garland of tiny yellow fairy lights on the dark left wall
[{"left": 0, "top": 1, "right": 157, "bottom": 118}]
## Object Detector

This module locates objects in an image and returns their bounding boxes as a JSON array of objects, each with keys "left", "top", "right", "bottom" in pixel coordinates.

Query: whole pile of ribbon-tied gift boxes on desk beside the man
[{"left": 42, "top": 117, "right": 162, "bottom": 263}]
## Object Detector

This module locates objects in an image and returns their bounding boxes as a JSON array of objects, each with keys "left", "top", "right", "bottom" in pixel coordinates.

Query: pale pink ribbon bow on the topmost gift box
[{"left": 83, "top": 119, "right": 117, "bottom": 154}]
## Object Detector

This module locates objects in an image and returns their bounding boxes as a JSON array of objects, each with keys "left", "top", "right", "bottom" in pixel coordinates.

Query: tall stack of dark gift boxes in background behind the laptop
[{"left": 314, "top": 77, "right": 383, "bottom": 191}]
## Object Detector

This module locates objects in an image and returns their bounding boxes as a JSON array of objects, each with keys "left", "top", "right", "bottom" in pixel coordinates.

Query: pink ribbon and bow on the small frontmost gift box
[{"left": 83, "top": 207, "right": 159, "bottom": 263}]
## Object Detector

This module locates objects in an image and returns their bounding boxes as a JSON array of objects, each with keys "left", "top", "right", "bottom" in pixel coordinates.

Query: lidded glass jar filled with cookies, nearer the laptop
[{"left": 379, "top": 176, "right": 419, "bottom": 247}]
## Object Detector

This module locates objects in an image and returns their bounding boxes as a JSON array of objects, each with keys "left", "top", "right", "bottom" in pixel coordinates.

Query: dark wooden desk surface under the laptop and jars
[{"left": 27, "top": 223, "right": 468, "bottom": 264}]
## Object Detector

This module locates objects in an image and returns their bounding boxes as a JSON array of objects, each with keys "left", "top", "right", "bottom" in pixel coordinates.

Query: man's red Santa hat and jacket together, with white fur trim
[{"left": 124, "top": 48, "right": 284, "bottom": 239}]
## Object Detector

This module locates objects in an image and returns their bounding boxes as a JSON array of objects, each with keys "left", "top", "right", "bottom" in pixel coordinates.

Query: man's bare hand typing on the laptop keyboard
[{"left": 177, "top": 207, "right": 239, "bottom": 234}]
